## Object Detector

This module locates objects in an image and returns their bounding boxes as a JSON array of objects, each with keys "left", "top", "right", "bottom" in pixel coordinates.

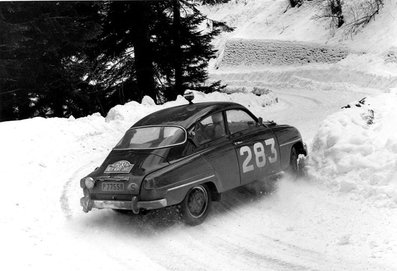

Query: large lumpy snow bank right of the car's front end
[{"left": 309, "top": 92, "right": 397, "bottom": 207}]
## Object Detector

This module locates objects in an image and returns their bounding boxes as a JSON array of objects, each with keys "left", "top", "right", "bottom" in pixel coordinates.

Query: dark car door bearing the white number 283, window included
[{"left": 225, "top": 109, "right": 280, "bottom": 184}]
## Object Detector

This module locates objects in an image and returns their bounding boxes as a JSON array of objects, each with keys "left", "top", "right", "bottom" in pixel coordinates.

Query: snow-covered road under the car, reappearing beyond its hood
[{"left": 42, "top": 83, "right": 390, "bottom": 270}]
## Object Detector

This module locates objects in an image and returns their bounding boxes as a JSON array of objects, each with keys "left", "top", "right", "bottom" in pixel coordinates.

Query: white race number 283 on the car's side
[{"left": 240, "top": 138, "right": 277, "bottom": 173}]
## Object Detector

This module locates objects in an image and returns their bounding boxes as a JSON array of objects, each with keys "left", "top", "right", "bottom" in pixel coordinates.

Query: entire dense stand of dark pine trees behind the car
[{"left": 0, "top": 0, "right": 230, "bottom": 121}]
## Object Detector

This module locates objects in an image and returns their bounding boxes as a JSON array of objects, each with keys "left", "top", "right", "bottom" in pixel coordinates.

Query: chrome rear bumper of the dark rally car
[{"left": 80, "top": 196, "right": 167, "bottom": 214}]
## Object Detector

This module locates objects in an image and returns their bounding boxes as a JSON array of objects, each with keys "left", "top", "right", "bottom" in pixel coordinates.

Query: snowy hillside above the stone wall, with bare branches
[{"left": 201, "top": 0, "right": 397, "bottom": 52}]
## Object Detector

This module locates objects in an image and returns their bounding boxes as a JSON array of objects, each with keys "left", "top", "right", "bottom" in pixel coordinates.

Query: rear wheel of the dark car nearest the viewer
[{"left": 180, "top": 185, "right": 212, "bottom": 226}]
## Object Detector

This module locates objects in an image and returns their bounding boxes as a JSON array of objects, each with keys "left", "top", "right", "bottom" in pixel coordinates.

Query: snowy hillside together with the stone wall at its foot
[{"left": 201, "top": 0, "right": 397, "bottom": 69}]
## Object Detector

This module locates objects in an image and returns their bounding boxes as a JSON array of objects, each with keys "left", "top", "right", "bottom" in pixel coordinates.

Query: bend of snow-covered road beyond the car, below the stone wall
[{"left": 211, "top": 65, "right": 388, "bottom": 140}]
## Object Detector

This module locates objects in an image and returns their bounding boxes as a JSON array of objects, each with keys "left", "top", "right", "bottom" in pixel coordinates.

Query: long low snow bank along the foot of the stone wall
[{"left": 210, "top": 63, "right": 397, "bottom": 93}]
